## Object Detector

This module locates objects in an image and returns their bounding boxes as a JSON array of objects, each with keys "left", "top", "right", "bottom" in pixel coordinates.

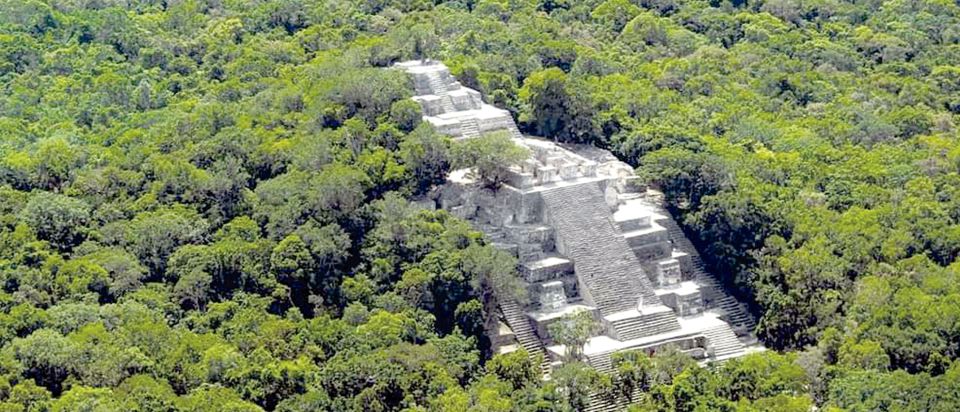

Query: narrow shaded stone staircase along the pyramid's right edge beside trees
[{"left": 657, "top": 217, "right": 757, "bottom": 335}]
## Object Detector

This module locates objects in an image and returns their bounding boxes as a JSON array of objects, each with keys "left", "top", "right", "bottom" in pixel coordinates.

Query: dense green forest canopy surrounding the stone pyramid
[{"left": 0, "top": 0, "right": 960, "bottom": 412}]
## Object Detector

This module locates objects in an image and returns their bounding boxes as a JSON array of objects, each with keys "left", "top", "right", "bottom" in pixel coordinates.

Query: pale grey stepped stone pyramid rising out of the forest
[{"left": 396, "top": 61, "right": 761, "bottom": 380}]
